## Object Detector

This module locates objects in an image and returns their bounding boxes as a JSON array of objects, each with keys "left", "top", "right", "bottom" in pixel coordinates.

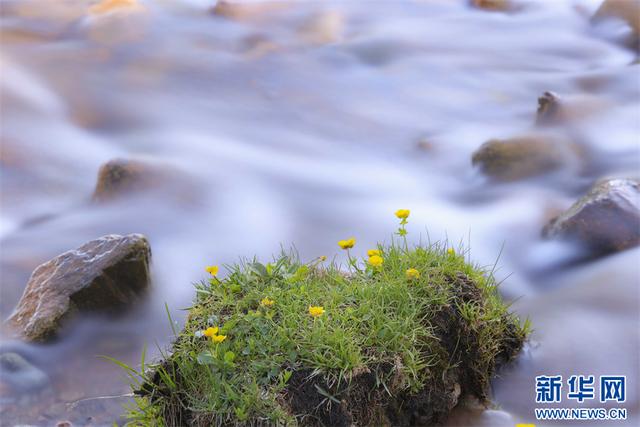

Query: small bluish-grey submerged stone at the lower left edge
[{"left": 0, "top": 352, "right": 49, "bottom": 394}]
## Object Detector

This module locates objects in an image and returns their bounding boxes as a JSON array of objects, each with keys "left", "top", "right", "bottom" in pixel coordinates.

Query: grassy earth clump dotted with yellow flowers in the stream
[{"left": 131, "top": 222, "right": 528, "bottom": 426}]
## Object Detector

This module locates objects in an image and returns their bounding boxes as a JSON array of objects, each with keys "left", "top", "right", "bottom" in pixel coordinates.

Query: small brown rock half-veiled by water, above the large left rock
[{"left": 93, "top": 159, "right": 161, "bottom": 201}]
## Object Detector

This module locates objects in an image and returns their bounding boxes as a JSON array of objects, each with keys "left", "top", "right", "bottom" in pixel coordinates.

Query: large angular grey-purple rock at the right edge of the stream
[{"left": 543, "top": 179, "right": 640, "bottom": 255}]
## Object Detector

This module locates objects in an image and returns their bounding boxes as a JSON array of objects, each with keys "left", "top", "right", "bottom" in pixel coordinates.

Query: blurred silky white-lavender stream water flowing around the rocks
[{"left": 0, "top": 0, "right": 640, "bottom": 426}]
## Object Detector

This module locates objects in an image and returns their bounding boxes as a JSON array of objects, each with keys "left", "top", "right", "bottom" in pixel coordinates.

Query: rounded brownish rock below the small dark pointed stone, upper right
[{"left": 471, "top": 135, "right": 579, "bottom": 181}]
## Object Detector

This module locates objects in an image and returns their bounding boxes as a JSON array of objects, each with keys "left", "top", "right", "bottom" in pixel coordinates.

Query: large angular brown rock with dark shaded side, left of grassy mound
[{"left": 9, "top": 234, "right": 151, "bottom": 341}]
